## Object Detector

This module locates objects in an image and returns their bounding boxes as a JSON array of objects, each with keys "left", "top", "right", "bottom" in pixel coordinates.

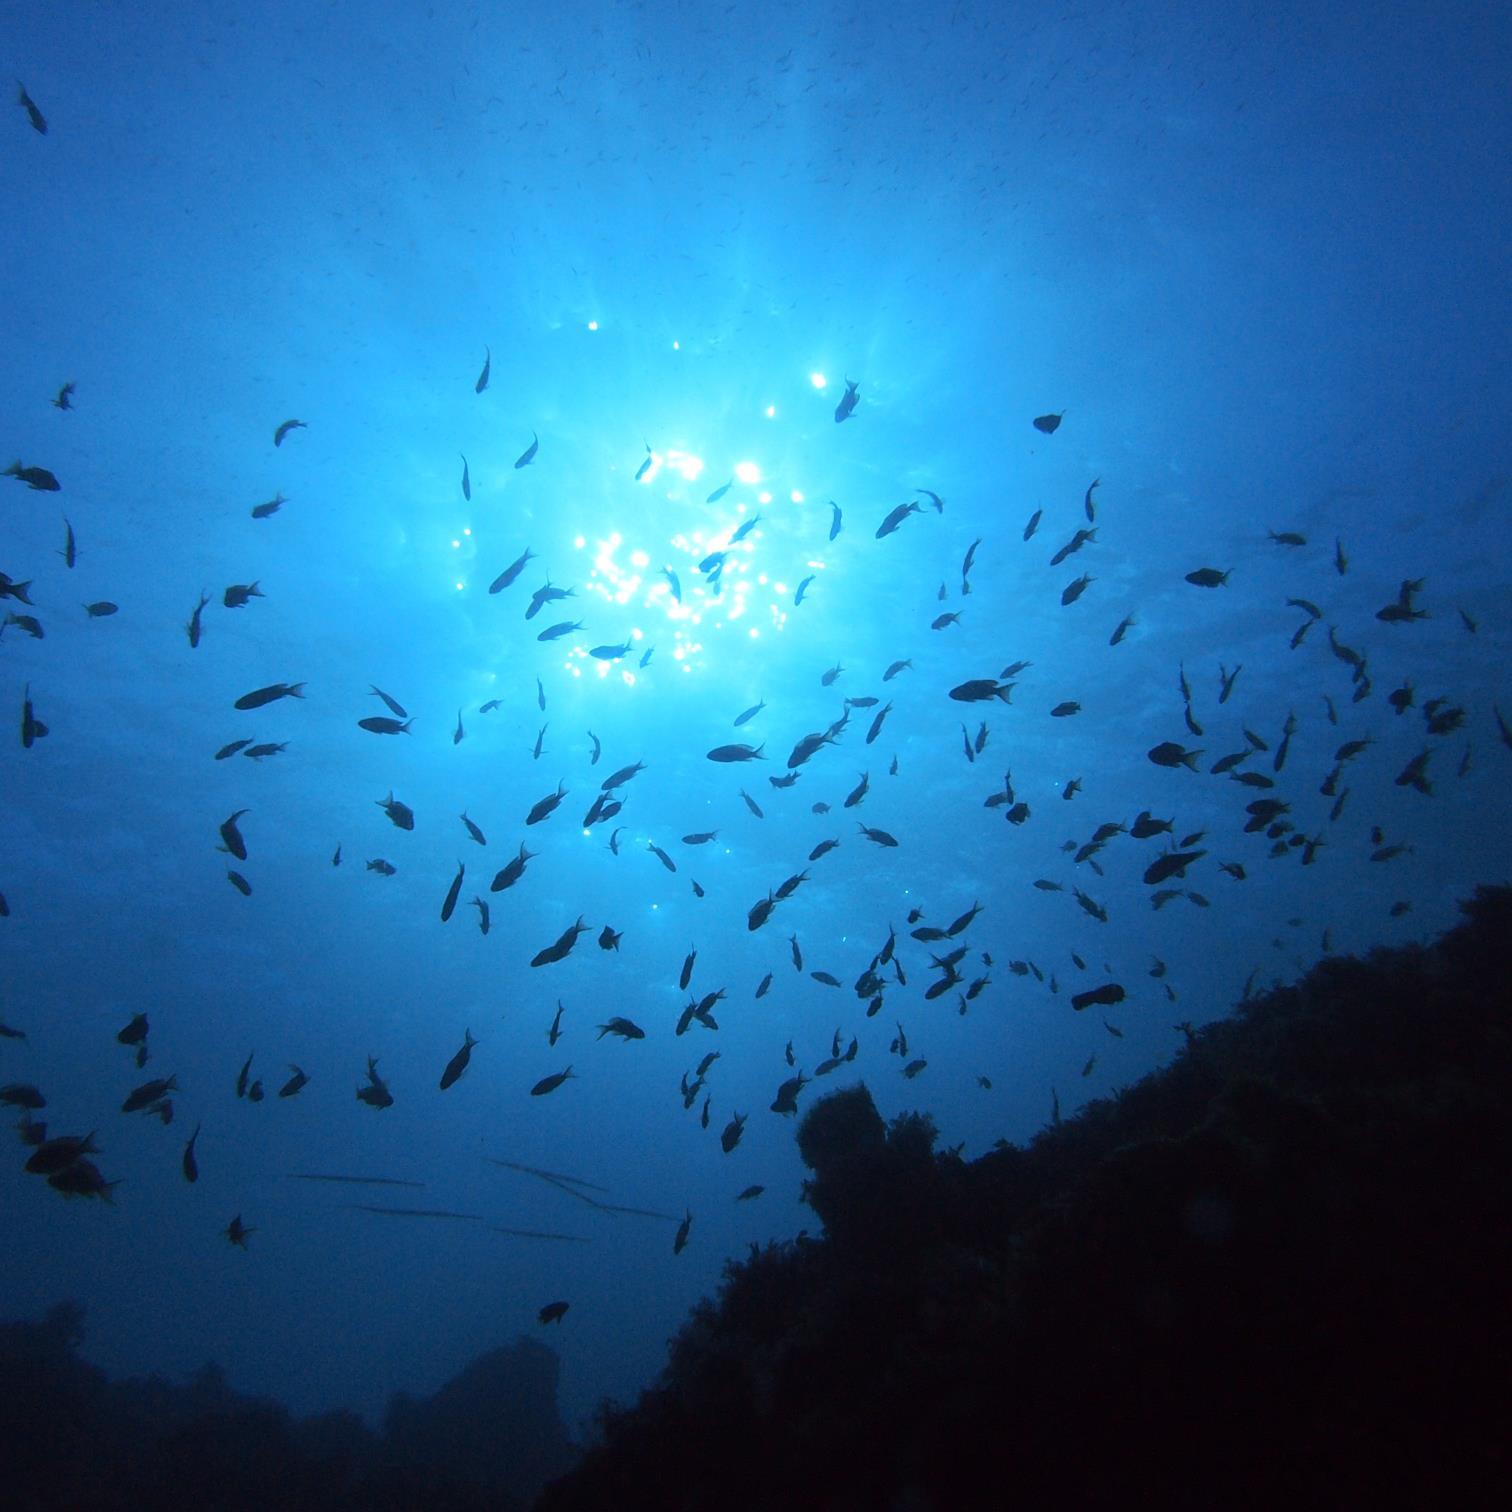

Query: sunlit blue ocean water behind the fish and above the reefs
[{"left": 0, "top": 5, "right": 1512, "bottom": 1439}]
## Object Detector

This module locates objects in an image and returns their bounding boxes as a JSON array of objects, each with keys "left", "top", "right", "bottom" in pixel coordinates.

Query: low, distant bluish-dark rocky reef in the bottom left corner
[{"left": 0, "top": 1303, "right": 575, "bottom": 1512}]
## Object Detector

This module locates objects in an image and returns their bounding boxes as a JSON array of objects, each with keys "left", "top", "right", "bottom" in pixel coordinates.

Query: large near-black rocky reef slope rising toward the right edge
[{"left": 538, "top": 888, "right": 1512, "bottom": 1512}]
